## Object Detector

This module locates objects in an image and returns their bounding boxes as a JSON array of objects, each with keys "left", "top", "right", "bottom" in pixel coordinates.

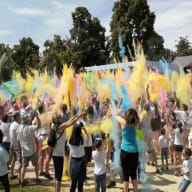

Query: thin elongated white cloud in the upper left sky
[{"left": 10, "top": 7, "right": 50, "bottom": 17}]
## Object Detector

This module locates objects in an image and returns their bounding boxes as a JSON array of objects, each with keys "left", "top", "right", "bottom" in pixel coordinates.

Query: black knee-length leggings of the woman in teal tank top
[{"left": 120, "top": 150, "right": 139, "bottom": 182}]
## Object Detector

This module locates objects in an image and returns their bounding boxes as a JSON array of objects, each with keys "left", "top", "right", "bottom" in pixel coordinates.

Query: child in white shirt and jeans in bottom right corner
[{"left": 179, "top": 149, "right": 192, "bottom": 192}]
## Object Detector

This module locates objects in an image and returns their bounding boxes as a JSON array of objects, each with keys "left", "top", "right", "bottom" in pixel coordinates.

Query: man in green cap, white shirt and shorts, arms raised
[{"left": 18, "top": 112, "right": 41, "bottom": 187}]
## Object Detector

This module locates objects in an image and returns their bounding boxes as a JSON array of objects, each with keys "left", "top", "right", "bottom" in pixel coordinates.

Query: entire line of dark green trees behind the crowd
[{"left": 0, "top": 0, "right": 192, "bottom": 82}]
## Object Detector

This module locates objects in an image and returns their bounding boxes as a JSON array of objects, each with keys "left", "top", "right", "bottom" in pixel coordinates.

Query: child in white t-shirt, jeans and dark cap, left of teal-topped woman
[{"left": 92, "top": 138, "right": 107, "bottom": 192}]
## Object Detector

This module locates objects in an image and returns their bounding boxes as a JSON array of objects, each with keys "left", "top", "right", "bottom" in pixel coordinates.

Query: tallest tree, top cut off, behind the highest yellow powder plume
[{"left": 110, "top": 0, "right": 155, "bottom": 59}]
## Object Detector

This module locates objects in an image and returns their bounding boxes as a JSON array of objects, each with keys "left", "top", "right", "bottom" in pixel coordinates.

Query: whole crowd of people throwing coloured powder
[{"left": 0, "top": 77, "right": 192, "bottom": 192}]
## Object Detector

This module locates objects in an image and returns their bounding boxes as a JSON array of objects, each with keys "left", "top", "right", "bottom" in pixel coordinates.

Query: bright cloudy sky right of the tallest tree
[{"left": 149, "top": 0, "right": 192, "bottom": 49}]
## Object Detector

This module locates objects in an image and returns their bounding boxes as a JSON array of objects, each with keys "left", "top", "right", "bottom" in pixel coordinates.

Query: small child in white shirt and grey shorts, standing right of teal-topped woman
[{"left": 159, "top": 128, "right": 168, "bottom": 171}]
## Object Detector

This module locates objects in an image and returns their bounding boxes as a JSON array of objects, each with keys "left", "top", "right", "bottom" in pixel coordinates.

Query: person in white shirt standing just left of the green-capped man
[{"left": 10, "top": 112, "right": 21, "bottom": 181}]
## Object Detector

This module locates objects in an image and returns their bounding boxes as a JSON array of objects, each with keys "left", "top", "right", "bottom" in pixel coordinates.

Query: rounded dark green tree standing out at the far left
[{"left": 12, "top": 37, "right": 40, "bottom": 78}]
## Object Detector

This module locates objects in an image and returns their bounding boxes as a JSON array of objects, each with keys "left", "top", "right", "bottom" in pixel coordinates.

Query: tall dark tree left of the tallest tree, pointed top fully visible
[{"left": 70, "top": 7, "right": 108, "bottom": 71}]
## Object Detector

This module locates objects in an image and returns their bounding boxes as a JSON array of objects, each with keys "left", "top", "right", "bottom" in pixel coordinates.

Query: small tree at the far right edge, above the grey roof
[{"left": 175, "top": 36, "right": 192, "bottom": 56}]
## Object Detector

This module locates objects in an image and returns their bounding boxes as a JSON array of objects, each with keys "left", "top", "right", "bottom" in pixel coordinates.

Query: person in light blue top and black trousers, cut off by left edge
[{"left": 0, "top": 130, "right": 10, "bottom": 192}]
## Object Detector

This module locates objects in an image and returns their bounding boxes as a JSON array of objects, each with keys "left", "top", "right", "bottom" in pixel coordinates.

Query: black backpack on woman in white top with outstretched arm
[{"left": 47, "top": 125, "right": 64, "bottom": 148}]
